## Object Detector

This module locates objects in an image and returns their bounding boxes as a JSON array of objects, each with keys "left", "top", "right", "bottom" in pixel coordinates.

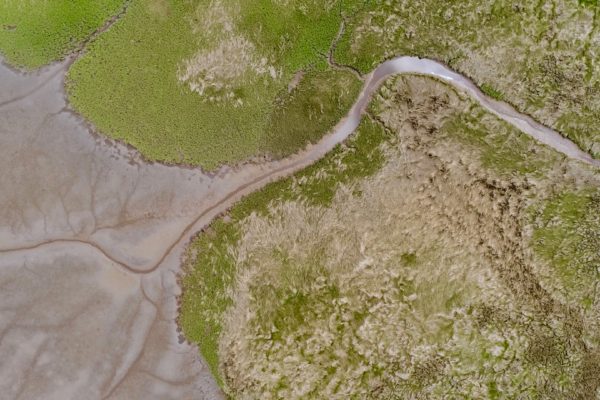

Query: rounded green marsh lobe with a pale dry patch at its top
[{"left": 68, "top": 0, "right": 361, "bottom": 169}]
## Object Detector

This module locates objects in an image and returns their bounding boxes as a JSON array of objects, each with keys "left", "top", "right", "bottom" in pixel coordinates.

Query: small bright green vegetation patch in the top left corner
[{"left": 0, "top": 0, "right": 124, "bottom": 69}]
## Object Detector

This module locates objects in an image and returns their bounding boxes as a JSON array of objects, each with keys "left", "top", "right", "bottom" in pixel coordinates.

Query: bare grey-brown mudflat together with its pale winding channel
[{"left": 0, "top": 57, "right": 600, "bottom": 400}]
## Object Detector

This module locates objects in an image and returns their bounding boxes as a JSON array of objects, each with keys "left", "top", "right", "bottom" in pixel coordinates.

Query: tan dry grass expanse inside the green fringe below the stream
[{"left": 193, "top": 77, "right": 598, "bottom": 399}]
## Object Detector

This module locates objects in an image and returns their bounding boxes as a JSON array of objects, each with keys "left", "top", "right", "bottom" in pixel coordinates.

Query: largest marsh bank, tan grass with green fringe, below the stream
[{"left": 180, "top": 76, "right": 600, "bottom": 399}]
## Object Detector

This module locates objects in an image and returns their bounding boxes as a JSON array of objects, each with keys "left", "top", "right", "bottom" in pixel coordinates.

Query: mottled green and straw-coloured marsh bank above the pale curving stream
[{"left": 335, "top": 0, "right": 600, "bottom": 158}]
